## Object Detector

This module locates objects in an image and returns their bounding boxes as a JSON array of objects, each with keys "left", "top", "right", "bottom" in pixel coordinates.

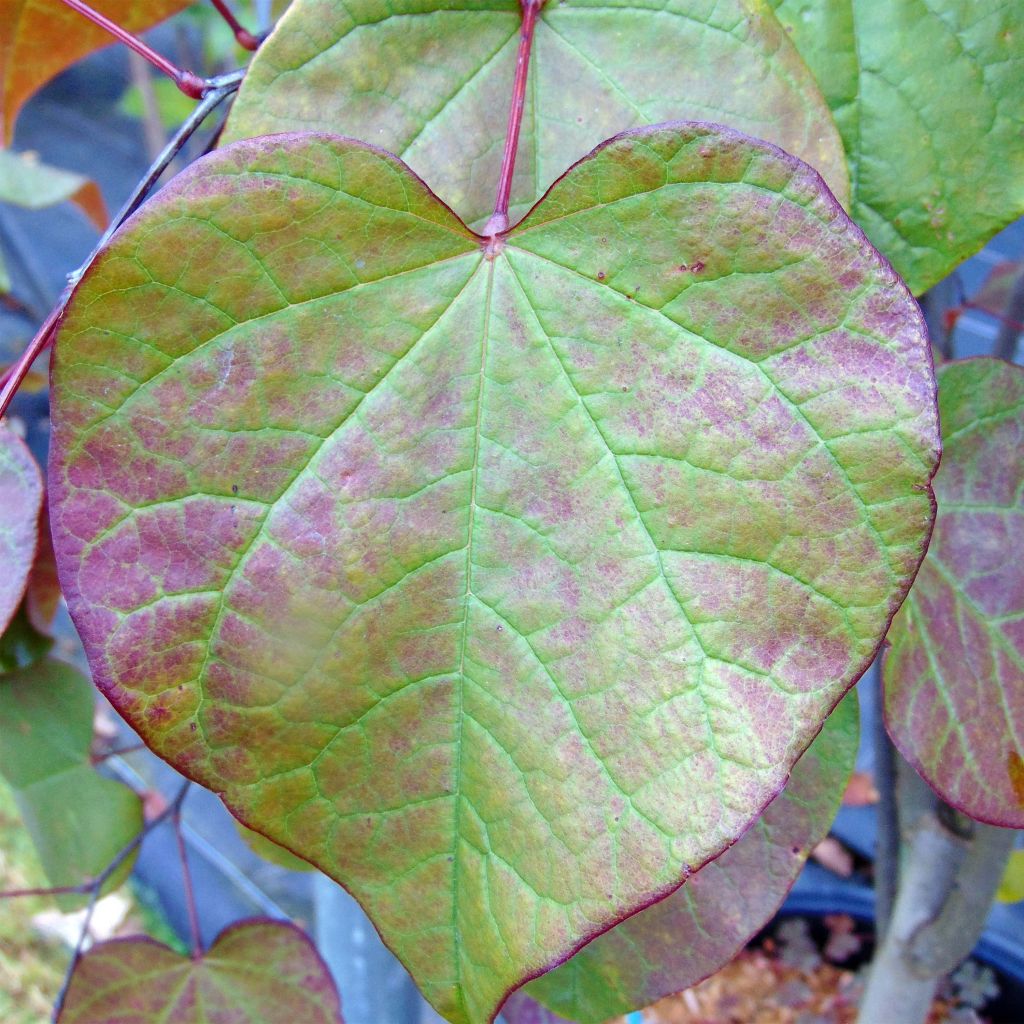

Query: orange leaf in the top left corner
[{"left": 0, "top": 0, "right": 191, "bottom": 142}]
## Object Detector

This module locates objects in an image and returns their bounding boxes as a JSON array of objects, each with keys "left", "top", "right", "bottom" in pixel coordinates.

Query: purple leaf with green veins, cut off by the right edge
[{"left": 885, "top": 359, "right": 1024, "bottom": 828}]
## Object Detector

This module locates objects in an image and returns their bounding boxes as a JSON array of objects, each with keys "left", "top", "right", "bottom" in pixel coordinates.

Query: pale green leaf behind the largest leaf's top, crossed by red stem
[{"left": 225, "top": 0, "right": 849, "bottom": 224}]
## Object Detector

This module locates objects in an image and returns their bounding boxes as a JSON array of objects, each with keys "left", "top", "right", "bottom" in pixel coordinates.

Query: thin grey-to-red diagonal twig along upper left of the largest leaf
[{"left": 0, "top": 71, "right": 245, "bottom": 417}]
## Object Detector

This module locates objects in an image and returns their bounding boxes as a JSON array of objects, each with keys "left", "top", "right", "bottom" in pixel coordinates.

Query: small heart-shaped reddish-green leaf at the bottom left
[{"left": 58, "top": 921, "right": 342, "bottom": 1024}]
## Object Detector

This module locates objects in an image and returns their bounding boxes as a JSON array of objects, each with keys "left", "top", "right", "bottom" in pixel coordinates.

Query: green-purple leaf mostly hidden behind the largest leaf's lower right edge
[{"left": 502, "top": 693, "right": 859, "bottom": 1024}]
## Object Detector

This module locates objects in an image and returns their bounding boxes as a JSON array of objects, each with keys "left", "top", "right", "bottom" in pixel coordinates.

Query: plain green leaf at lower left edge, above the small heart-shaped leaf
[{"left": 0, "top": 660, "right": 142, "bottom": 906}]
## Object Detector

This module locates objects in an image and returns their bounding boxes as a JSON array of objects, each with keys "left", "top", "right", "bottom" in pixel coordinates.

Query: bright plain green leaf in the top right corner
[{"left": 768, "top": 0, "right": 1024, "bottom": 294}]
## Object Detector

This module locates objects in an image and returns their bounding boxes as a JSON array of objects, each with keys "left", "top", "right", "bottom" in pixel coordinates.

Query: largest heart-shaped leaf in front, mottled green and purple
[{"left": 51, "top": 124, "right": 938, "bottom": 1024}]
